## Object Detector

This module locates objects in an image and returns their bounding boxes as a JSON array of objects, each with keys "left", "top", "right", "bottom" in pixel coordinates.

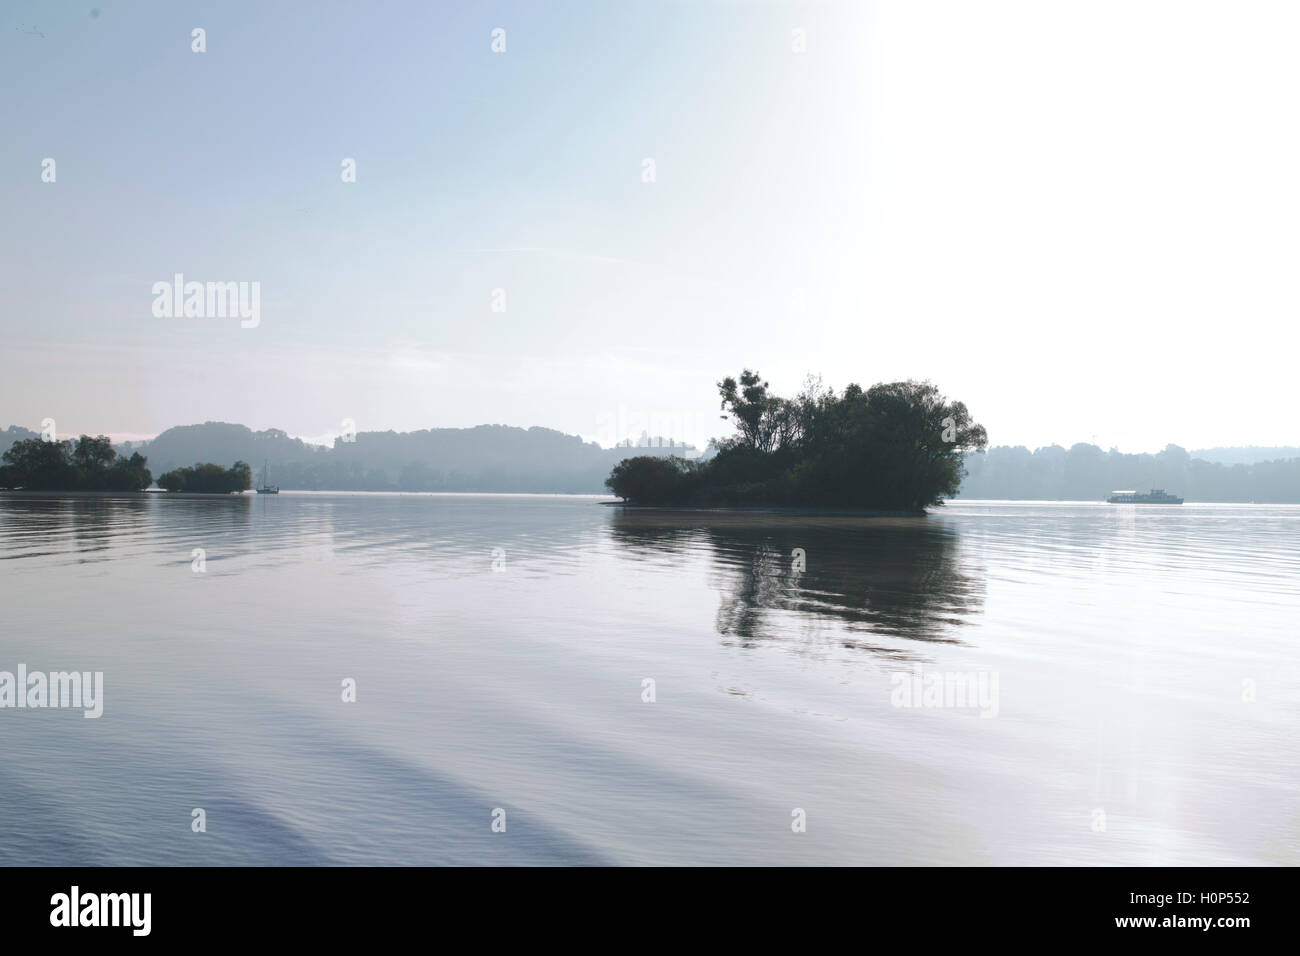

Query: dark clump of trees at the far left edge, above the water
[{"left": 0, "top": 434, "right": 153, "bottom": 492}]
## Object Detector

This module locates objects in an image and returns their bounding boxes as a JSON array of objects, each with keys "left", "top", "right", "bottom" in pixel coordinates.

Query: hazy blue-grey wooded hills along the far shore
[{"left": 0, "top": 421, "right": 1300, "bottom": 502}]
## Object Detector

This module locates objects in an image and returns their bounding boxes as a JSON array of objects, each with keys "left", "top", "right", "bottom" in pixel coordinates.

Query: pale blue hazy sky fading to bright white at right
[{"left": 0, "top": 0, "right": 1300, "bottom": 451}]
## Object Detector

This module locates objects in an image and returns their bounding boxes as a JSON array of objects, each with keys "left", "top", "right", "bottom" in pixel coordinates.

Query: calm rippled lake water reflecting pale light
[{"left": 0, "top": 492, "right": 1300, "bottom": 865}]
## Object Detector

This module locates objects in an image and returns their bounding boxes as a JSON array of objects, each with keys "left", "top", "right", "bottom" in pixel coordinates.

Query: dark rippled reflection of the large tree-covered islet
[{"left": 610, "top": 509, "right": 984, "bottom": 658}]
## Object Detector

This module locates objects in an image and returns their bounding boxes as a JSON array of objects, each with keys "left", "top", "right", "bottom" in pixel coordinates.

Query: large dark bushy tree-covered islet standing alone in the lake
[{"left": 605, "top": 368, "right": 988, "bottom": 512}]
